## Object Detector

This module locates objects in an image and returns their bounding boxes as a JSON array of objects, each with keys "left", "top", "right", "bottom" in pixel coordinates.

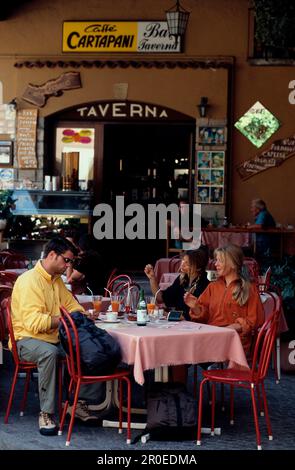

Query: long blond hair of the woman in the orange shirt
[{"left": 214, "top": 245, "right": 251, "bottom": 306}]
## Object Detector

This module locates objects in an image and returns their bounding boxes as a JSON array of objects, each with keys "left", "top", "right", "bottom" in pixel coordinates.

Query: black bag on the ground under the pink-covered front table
[{"left": 146, "top": 382, "right": 197, "bottom": 441}]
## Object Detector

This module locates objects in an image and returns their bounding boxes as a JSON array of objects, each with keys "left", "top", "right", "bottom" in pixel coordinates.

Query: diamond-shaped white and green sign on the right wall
[{"left": 235, "top": 101, "right": 280, "bottom": 148}]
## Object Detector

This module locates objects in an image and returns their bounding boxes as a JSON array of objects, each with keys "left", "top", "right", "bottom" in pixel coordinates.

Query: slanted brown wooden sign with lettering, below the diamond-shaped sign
[{"left": 237, "top": 135, "right": 295, "bottom": 180}]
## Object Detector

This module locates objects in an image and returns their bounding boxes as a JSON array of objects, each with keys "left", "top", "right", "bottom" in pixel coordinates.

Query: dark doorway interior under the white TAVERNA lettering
[{"left": 102, "top": 123, "right": 194, "bottom": 270}]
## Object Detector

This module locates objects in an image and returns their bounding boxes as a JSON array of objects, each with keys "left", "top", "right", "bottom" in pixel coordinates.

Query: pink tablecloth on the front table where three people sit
[{"left": 108, "top": 321, "right": 248, "bottom": 385}]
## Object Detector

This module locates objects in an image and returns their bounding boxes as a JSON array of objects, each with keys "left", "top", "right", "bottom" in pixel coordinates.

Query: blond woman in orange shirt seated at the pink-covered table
[{"left": 184, "top": 245, "right": 264, "bottom": 354}]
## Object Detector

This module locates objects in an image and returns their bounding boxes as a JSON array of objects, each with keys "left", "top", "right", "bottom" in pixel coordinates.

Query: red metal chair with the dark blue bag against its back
[{"left": 58, "top": 307, "right": 131, "bottom": 446}]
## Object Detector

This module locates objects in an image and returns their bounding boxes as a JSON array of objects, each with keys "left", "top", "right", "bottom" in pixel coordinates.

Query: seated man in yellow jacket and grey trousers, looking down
[{"left": 11, "top": 237, "right": 97, "bottom": 436}]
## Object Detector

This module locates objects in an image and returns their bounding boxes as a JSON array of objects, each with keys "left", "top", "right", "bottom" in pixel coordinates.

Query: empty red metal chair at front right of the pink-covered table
[{"left": 197, "top": 304, "right": 280, "bottom": 450}]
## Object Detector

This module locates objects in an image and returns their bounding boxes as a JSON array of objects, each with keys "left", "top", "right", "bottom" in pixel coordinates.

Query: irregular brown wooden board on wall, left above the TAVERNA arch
[{"left": 22, "top": 72, "right": 81, "bottom": 108}]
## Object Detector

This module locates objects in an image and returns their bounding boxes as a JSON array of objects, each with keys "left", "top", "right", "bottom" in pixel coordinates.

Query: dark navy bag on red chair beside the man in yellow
[{"left": 59, "top": 312, "right": 121, "bottom": 376}]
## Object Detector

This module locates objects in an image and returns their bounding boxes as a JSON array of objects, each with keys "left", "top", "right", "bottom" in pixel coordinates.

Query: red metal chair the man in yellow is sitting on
[{"left": 4, "top": 298, "right": 64, "bottom": 424}]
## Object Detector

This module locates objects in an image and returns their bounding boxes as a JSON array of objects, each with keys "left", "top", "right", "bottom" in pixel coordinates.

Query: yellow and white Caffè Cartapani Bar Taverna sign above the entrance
[{"left": 62, "top": 20, "right": 181, "bottom": 53}]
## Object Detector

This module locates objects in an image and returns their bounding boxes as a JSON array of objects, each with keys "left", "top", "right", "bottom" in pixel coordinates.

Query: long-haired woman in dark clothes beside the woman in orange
[{"left": 144, "top": 247, "right": 209, "bottom": 320}]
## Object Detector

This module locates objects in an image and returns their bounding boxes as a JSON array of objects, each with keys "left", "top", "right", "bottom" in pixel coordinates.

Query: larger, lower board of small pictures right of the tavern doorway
[{"left": 195, "top": 150, "right": 225, "bottom": 204}]
